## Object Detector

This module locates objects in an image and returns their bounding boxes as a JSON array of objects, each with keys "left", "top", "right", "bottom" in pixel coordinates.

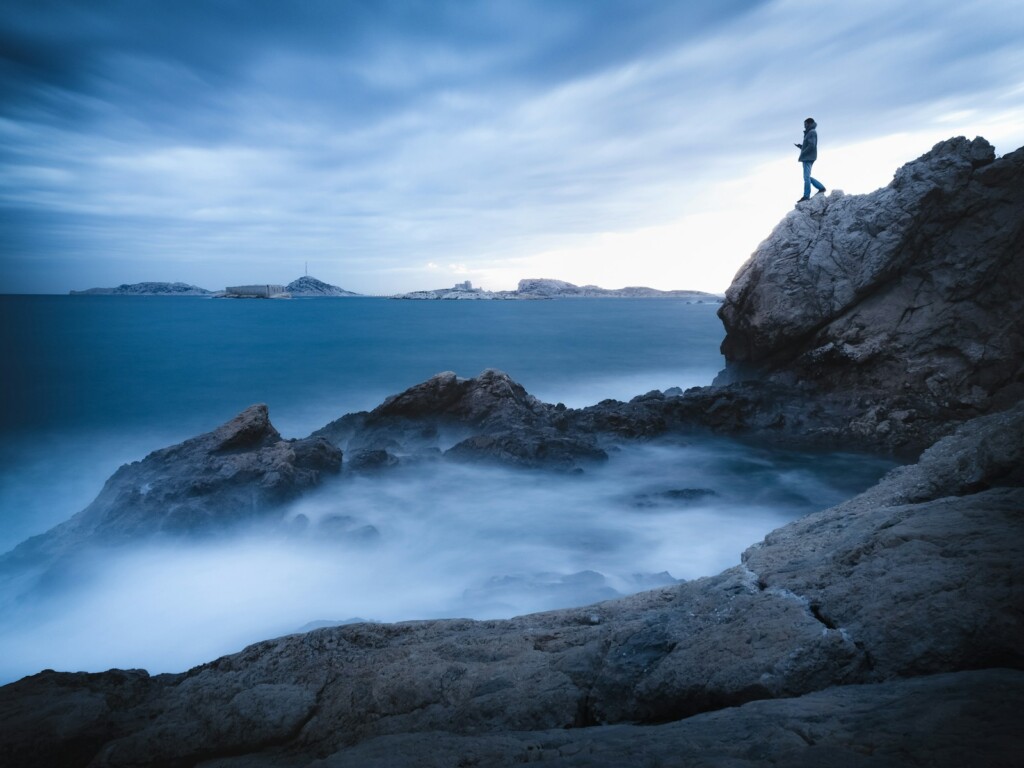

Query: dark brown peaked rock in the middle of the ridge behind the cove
[{"left": 313, "top": 369, "right": 607, "bottom": 469}]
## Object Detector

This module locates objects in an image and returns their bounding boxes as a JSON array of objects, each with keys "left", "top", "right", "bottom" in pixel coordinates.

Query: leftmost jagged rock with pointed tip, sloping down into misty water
[{"left": 0, "top": 404, "right": 341, "bottom": 570}]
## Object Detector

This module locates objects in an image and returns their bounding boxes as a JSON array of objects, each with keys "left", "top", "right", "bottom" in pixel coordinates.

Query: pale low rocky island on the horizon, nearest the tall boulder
[{"left": 391, "top": 278, "right": 724, "bottom": 303}]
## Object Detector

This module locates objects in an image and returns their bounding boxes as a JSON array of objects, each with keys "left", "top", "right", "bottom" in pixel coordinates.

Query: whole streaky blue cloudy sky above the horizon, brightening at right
[{"left": 0, "top": 0, "right": 1024, "bottom": 294}]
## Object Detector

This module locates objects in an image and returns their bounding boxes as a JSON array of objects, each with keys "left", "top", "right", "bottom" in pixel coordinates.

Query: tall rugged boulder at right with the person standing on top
[{"left": 719, "top": 137, "right": 1024, "bottom": 444}]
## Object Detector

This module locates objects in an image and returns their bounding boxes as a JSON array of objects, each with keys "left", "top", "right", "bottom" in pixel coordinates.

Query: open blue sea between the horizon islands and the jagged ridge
[{"left": 0, "top": 296, "right": 723, "bottom": 551}]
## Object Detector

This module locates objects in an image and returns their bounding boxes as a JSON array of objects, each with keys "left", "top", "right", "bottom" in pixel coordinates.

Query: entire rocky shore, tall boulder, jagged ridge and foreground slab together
[{"left": 0, "top": 137, "right": 1024, "bottom": 768}]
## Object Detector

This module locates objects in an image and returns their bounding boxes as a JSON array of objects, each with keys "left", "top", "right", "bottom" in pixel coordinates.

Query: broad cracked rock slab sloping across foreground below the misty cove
[{"left": 0, "top": 406, "right": 1024, "bottom": 766}]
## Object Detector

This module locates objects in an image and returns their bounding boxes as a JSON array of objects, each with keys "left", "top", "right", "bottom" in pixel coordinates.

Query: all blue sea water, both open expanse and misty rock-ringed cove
[{"left": 0, "top": 296, "right": 892, "bottom": 682}]
